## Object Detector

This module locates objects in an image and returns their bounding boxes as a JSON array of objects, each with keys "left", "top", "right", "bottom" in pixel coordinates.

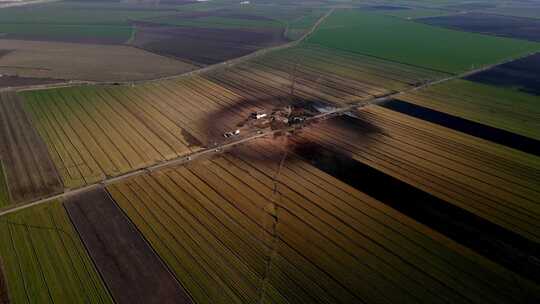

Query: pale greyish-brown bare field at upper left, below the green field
[{"left": 0, "top": 39, "right": 196, "bottom": 81}]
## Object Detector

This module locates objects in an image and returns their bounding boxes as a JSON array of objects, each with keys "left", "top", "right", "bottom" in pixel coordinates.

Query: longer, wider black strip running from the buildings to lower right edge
[{"left": 293, "top": 123, "right": 540, "bottom": 281}]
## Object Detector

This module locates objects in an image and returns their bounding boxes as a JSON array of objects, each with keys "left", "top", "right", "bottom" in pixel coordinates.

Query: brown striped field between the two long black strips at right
[{"left": 302, "top": 106, "right": 540, "bottom": 242}]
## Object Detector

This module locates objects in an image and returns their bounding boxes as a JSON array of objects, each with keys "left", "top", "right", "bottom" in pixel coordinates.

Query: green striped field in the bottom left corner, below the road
[{"left": 0, "top": 202, "right": 113, "bottom": 304}]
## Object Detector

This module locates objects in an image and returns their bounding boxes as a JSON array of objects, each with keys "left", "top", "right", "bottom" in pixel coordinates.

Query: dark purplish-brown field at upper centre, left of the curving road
[{"left": 133, "top": 23, "right": 286, "bottom": 64}]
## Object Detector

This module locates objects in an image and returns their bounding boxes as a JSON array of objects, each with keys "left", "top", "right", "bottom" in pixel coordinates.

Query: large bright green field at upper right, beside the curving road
[{"left": 307, "top": 10, "right": 540, "bottom": 73}]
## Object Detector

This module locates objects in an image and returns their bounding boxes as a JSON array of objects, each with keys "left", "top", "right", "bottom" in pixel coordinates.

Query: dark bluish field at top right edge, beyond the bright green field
[{"left": 415, "top": 13, "right": 540, "bottom": 41}]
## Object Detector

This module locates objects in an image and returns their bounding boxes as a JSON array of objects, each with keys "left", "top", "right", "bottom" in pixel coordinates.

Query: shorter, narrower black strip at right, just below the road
[{"left": 382, "top": 99, "right": 540, "bottom": 156}]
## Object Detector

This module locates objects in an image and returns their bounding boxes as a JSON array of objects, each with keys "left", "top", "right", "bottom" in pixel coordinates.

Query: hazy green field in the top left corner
[{"left": 0, "top": 2, "right": 175, "bottom": 44}]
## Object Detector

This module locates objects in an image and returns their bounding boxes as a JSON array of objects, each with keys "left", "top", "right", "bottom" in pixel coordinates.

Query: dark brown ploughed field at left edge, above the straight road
[{"left": 0, "top": 93, "right": 63, "bottom": 203}]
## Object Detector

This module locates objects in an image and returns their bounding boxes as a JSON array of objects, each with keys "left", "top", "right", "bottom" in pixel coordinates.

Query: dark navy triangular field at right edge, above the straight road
[{"left": 465, "top": 53, "right": 540, "bottom": 96}]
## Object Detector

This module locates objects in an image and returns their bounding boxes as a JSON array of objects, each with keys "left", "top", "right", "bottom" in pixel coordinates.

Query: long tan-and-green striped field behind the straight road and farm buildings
[{"left": 16, "top": 43, "right": 452, "bottom": 188}]
